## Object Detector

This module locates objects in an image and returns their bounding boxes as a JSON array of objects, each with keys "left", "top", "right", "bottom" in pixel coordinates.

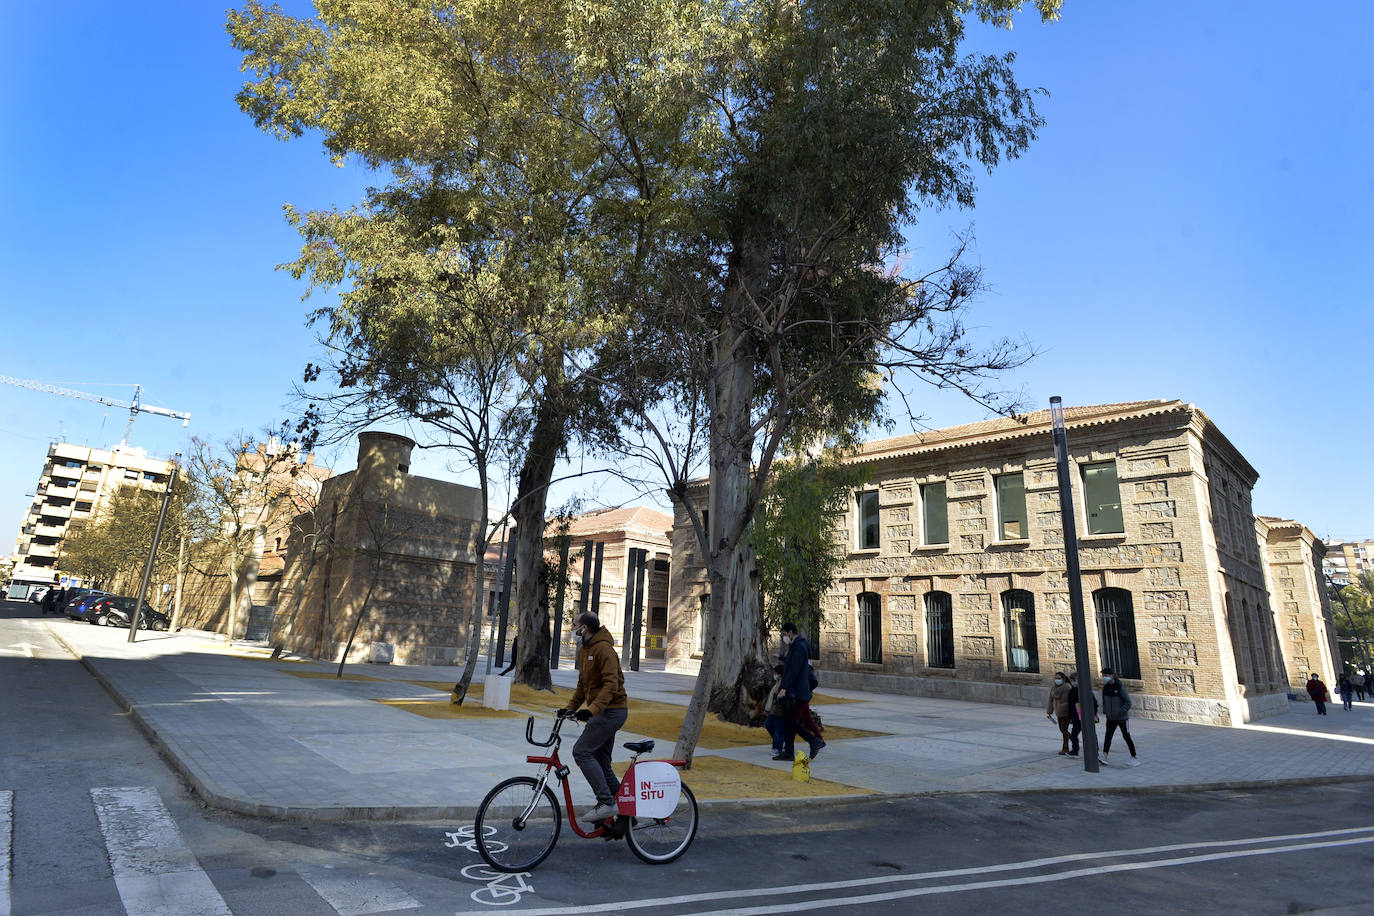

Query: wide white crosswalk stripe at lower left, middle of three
[{"left": 91, "top": 786, "right": 232, "bottom": 916}]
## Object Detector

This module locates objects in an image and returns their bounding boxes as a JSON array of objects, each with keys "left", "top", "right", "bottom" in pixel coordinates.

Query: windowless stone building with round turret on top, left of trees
[{"left": 271, "top": 433, "right": 481, "bottom": 665}]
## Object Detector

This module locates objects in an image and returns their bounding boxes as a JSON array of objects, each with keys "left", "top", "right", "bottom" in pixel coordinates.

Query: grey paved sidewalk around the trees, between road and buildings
[{"left": 47, "top": 621, "right": 1374, "bottom": 820}]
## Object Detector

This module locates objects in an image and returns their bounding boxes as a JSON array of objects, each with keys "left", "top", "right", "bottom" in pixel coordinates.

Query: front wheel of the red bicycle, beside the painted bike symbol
[{"left": 473, "top": 776, "right": 563, "bottom": 872}]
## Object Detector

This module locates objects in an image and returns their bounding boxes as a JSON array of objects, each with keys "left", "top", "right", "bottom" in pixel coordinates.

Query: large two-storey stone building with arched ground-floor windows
[{"left": 669, "top": 401, "right": 1331, "bottom": 724}]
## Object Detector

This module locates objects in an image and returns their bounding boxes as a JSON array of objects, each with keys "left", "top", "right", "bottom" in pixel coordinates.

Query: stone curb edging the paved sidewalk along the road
[{"left": 44, "top": 623, "right": 1374, "bottom": 823}]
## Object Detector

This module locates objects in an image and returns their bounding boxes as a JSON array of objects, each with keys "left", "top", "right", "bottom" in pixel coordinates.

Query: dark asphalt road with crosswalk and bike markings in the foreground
[{"left": 0, "top": 603, "right": 1374, "bottom": 916}]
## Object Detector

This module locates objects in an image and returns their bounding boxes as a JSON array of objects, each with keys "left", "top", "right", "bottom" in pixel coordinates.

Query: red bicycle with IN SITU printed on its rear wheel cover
[{"left": 473, "top": 714, "right": 697, "bottom": 872}]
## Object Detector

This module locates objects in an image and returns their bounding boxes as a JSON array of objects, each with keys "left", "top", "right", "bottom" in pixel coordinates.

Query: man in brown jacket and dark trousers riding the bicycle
[{"left": 558, "top": 611, "right": 629, "bottom": 824}]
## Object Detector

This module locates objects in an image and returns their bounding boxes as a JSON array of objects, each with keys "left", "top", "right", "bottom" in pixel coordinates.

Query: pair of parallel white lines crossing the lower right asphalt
[{"left": 458, "top": 827, "right": 1374, "bottom": 916}]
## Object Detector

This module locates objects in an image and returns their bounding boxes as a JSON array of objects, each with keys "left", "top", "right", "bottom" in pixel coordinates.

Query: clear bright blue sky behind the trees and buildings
[{"left": 0, "top": 0, "right": 1374, "bottom": 551}]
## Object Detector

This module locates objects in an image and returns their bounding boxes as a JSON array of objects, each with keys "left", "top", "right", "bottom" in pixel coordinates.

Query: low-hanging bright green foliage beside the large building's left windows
[{"left": 750, "top": 450, "right": 868, "bottom": 632}]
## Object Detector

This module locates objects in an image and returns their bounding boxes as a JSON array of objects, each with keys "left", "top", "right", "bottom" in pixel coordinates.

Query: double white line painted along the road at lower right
[{"left": 458, "top": 825, "right": 1374, "bottom": 916}]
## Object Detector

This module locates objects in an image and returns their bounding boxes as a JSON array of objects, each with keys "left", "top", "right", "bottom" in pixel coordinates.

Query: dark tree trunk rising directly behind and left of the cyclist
[{"left": 511, "top": 394, "right": 567, "bottom": 689}]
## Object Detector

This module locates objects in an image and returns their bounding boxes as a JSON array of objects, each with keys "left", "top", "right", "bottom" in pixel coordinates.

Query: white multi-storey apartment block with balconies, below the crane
[{"left": 11, "top": 442, "right": 172, "bottom": 585}]
